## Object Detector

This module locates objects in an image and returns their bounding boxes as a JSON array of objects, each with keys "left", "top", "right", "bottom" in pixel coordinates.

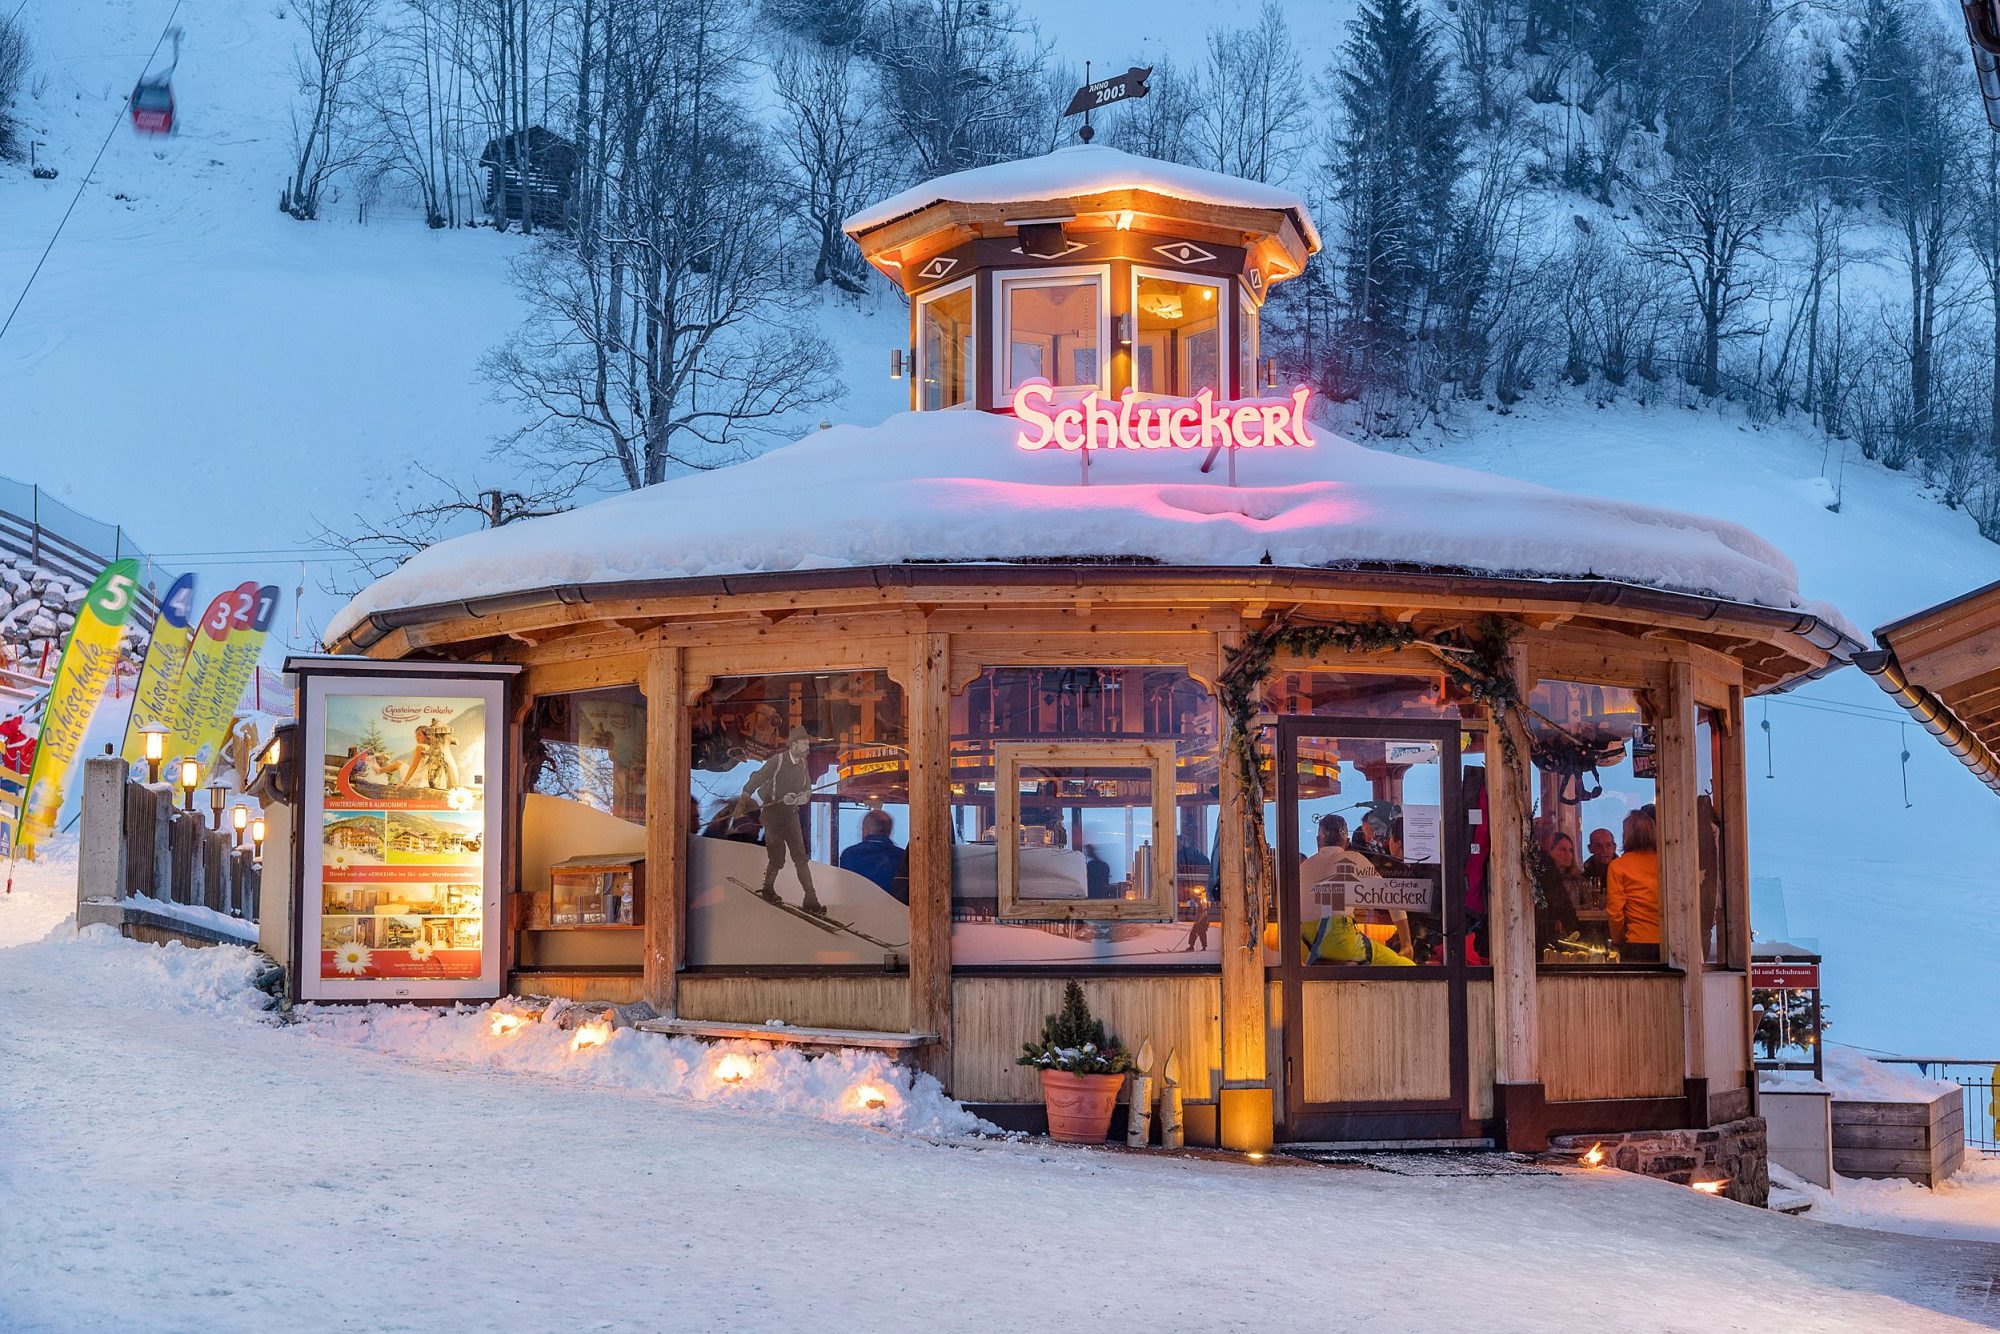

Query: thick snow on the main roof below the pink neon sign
[{"left": 328, "top": 412, "right": 1852, "bottom": 644}]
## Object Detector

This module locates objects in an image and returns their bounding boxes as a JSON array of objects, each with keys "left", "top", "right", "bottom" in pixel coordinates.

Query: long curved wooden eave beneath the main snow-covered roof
[{"left": 334, "top": 564, "right": 1860, "bottom": 694}]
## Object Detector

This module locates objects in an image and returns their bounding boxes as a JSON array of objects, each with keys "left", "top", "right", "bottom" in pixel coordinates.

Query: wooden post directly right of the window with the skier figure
[{"left": 906, "top": 632, "right": 952, "bottom": 1088}]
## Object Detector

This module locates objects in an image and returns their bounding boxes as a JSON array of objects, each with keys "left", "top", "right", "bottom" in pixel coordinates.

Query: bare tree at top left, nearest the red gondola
[{"left": 280, "top": 0, "right": 380, "bottom": 220}]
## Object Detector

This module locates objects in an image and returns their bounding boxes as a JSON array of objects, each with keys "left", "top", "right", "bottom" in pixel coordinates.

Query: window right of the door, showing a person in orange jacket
[{"left": 1528, "top": 680, "right": 1664, "bottom": 964}]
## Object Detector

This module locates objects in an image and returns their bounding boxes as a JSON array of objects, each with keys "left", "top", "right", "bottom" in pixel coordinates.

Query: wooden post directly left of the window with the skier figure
[{"left": 642, "top": 646, "right": 696, "bottom": 1018}]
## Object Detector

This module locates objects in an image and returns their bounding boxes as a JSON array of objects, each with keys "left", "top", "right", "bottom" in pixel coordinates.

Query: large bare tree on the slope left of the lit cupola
[{"left": 488, "top": 0, "right": 840, "bottom": 488}]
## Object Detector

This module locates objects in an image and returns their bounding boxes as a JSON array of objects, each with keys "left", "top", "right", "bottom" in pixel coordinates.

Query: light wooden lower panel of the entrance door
[{"left": 1298, "top": 980, "right": 1452, "bottom": 1102}]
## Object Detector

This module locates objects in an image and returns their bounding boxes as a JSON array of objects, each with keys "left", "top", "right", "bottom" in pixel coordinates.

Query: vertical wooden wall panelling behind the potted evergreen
[{"left": 950, "top": 976, "right": 1222, "bottom": 1102}]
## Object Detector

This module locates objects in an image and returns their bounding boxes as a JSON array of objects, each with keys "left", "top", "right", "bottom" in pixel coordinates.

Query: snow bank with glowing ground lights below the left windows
[{"left": 294, "top": 1000, "right": 998, "bottom": 1136}]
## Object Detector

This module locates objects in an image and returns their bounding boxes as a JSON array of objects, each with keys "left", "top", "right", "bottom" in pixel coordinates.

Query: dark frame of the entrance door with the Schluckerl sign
[{"left": 1274, "top": 716, "right": 1476, "bottom": 1142}]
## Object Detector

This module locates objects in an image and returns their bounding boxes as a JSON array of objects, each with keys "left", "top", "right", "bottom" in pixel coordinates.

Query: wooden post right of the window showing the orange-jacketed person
[{"left": 1658, "top": 662, "right": 1708, "bottom": 1126}]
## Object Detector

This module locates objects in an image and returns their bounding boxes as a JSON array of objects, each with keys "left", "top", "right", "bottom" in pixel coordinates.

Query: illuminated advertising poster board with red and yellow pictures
[{"left": 302, "top": 680, "right": 500, "bottom": 1000}]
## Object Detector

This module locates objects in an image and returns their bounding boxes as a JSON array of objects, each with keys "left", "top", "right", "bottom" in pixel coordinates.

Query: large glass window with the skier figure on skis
[{"left": 688, "top": 672, "right": 910, "bottom": 968}]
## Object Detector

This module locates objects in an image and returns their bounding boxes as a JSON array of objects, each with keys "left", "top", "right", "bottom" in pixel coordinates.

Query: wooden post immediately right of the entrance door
[{"left": 1482, "top": 644, "right": 1548, "bottom": 1152}]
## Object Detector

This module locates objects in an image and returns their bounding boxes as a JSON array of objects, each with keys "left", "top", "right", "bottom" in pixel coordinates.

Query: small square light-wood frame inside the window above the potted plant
[{"left": 994, "top": 740, "right": 1176, "bottom": 922}]
